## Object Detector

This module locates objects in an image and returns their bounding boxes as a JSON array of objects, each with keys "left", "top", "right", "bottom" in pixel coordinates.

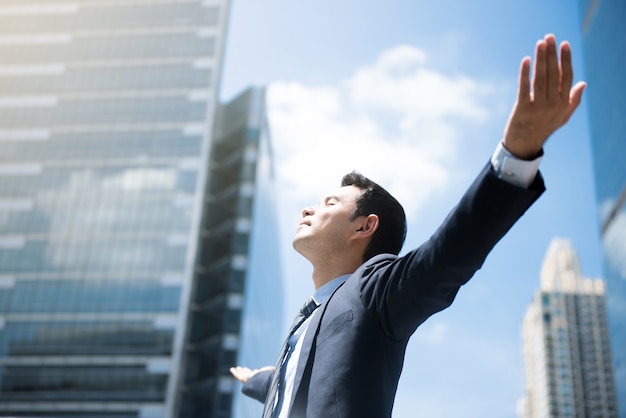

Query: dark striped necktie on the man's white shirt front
[{"left": 263, "top": 296, "right": 319, "bottom": 418}]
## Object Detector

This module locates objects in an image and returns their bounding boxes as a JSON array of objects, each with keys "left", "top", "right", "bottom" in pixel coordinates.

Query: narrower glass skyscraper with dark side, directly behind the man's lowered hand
[{"left": 177, "top": 89, "right": 282, "bottom": 418}]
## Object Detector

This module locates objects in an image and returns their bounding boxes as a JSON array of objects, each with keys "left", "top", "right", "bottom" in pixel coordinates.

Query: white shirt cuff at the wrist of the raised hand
[{"left": 491, "top": 142, "right": 543, "bottom": 189}]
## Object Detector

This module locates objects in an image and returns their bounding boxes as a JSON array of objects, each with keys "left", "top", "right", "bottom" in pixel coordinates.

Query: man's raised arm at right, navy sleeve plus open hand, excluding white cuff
[{"left": 362, "top": 35, "right": 585, "bottom": 340}]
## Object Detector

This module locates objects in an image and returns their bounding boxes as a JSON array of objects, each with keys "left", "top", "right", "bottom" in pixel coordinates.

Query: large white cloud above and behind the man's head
[{"left": 268, "top": 45, "right": 494, "bottom": 216}]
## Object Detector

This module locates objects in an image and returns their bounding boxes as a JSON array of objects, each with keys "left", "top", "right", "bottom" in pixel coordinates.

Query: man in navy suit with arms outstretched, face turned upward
[{"left": 231, "top": 35, "right": 585, "bottom": 418}]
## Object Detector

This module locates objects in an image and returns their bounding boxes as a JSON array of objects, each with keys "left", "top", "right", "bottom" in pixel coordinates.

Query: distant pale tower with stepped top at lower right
[{"left": 520, "top": 239, "right": 617, "bottom": 418}]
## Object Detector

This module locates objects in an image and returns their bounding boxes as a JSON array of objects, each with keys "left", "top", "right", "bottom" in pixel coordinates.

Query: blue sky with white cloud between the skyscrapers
[{"left": 221, "top": 0, "right": 602, "bottom": 418}]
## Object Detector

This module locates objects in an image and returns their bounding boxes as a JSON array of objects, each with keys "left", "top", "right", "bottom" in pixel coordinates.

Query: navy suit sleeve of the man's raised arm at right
[{"left": 360, "top": 164, "right": 545, "bottom": 341}]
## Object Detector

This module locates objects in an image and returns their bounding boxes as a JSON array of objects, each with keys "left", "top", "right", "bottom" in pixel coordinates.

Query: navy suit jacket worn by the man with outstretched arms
[{"left": 243, "top": 164, "right": 545, "bottom": 418}]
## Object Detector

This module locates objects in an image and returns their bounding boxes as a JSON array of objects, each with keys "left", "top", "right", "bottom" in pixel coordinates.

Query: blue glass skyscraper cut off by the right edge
[{"left": 579, "top": 0, "right": 626, "bottom": 418}]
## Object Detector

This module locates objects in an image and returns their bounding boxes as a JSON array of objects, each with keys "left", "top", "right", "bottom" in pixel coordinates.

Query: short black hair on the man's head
[{"left": 341, "top": 171, "right": 406, "bottom": 261}]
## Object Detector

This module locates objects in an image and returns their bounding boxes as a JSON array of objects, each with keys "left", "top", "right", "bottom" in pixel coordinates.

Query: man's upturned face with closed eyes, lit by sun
[{"left": 293, "top": 186, "right": 362, "bottom": 260}]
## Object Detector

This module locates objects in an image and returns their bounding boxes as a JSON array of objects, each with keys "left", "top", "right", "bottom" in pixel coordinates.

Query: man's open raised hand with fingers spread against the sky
[{"left": 503, "top": 34, "right": 586, "bottom": 159}]
